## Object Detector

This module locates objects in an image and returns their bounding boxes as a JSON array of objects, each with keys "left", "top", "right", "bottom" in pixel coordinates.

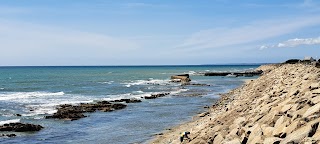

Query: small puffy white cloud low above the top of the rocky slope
[{"left": 260, "top": 37, "right": 320, "bottom": 50}]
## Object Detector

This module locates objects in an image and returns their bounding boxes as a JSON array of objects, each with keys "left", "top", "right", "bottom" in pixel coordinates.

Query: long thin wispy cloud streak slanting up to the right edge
[{"left": 176, "top": 16, "right": 320, "bottom": 51}]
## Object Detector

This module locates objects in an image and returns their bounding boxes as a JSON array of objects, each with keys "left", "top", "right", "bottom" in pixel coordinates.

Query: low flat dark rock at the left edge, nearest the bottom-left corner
[{"left": 0, "top": 123, "right": 43, "bottom": 132}]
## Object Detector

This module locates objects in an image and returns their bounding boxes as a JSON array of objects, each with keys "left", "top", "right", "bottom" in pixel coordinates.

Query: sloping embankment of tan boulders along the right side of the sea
[{"left": 150, "top": 64, "right": 320, "bottom": 144}]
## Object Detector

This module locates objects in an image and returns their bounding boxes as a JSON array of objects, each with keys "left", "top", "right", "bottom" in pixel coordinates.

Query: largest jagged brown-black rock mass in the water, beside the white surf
[{"left": 45, "top": 101, "right": 127, "bottom": 120}]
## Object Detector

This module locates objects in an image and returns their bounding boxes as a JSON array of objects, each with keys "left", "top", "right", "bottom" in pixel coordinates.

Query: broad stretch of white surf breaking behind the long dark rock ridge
[{"left": 0, "top": 88, "right": 187, "bottom": 119}]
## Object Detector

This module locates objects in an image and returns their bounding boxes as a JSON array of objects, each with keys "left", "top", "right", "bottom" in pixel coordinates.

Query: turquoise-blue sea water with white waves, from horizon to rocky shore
[{"left": 0, "top": 65, "right": 258, "bottom": 144}]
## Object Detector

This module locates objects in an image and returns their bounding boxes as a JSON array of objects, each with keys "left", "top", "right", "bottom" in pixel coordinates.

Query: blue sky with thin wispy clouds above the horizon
[{"left": 0, "top": 0, "right": 320, "bottom": 66}]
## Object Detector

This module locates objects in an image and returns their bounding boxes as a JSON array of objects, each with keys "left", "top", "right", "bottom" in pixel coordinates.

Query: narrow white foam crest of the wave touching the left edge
[{"left": 0, "top": 92, "right": 64, "bottom": 101}]
